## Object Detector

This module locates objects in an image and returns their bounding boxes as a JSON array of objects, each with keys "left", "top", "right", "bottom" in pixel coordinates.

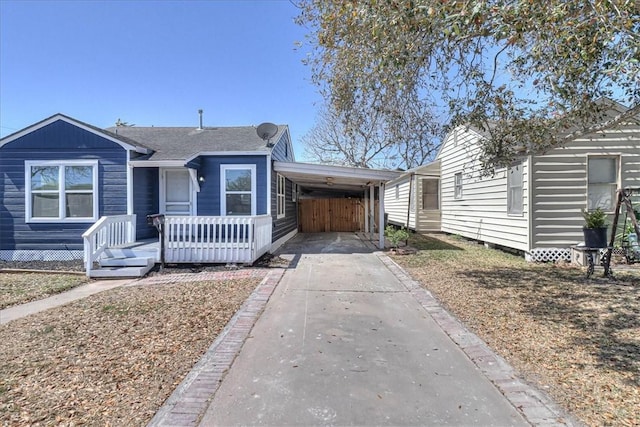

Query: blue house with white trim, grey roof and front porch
[{"left": 0, "top": 114, "right": 298, "bottom": 276}]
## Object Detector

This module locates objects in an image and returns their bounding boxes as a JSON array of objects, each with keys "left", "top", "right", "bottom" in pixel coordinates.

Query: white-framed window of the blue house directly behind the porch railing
[{"left": 220, "top": 165, "right": 256, "bottom": 216}]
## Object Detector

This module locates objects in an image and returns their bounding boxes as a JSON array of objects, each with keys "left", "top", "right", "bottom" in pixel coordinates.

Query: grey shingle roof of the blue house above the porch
[{"left": 106, "top": 125, "right": 286, "bottom": 160}]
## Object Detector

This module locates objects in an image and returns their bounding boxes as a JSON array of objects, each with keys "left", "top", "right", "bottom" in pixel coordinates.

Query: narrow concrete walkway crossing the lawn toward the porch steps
[{"left": 0, "top": 279, "right": 132, "bottom": 325}]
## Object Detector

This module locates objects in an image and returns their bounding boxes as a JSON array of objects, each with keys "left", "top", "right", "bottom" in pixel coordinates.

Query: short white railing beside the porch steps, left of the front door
[{"left": 82, "top": 215, "right": 136, "bottom": 276}]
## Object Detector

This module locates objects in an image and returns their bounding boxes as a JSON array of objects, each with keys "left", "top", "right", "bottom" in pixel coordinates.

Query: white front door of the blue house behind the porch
[{"left": 160, "top": 169, "right": 195, "bottom": 216}]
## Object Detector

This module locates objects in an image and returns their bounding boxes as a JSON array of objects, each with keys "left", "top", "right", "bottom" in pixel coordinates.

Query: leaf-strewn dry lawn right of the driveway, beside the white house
[{"left": 393, "top": 235, "right": 640, "bottom": 426}]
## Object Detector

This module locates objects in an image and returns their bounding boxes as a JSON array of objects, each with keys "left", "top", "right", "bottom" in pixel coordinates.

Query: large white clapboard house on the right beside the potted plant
[{"left": 440, "top": 104, "right": 640, "bottom": 261}]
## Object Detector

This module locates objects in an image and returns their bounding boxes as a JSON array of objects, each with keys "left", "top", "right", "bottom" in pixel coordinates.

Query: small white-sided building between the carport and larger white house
[{"left": 384, "top": 161, "right": 440, "bottom": 233}]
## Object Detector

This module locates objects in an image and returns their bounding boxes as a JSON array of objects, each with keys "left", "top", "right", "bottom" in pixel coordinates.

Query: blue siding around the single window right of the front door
[{"left": 192, "top": 155, "right": 268, "bottom": 216}]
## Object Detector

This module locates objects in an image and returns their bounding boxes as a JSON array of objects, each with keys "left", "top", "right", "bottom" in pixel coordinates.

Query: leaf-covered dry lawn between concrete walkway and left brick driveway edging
[{"left": 0, "top": 278, "right": 260, "bottom": 426}]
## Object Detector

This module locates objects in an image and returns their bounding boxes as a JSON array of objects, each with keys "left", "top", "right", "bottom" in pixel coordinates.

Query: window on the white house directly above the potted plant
[{"left": 587, "top": 157, "right": 618, "bottom": 211}]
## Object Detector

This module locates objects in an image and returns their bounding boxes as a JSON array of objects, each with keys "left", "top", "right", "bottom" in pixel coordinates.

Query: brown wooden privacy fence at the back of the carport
[{"left": 298, "top": 198, "right": 378, "bottom": 233}]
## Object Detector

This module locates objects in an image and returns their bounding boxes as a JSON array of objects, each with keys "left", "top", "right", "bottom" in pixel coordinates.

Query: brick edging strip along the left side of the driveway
[{"left": 148, "top": 268, "right": 286, "bottom": 427}]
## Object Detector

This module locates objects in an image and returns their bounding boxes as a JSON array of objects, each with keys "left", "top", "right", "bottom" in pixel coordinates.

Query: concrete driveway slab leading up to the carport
[{"left": 201, "top": 233, "right": 529, "bottom": 426}]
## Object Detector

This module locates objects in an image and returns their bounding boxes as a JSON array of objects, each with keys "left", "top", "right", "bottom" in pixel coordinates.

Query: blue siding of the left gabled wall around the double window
[{"left": 0, "top": 120, "right": 127, "bottom": 250}]
